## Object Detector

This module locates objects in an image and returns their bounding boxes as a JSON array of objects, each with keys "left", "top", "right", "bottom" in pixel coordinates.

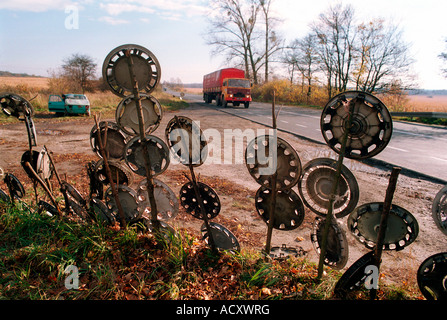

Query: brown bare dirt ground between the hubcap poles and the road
[{"left": 0, "top": 105, "right": 447, "bottom": 290}]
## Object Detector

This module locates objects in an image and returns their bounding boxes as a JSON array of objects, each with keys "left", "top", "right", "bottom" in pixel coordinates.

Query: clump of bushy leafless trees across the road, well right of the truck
[{"left": 311, "top": 3, "right": 413, "bottom": 98}]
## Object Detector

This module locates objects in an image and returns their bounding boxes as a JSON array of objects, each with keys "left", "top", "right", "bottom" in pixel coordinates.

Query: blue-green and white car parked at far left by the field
[{"left": 48, "top": 93, "right": 90, "bottom": 116}]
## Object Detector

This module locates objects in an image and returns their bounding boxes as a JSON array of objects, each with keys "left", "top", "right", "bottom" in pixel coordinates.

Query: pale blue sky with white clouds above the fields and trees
[{"left": 0, "top": 0, "right": 447, "bottom": 89}]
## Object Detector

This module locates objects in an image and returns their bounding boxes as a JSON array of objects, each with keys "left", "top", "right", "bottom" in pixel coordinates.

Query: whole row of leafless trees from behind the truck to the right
[{"left": 205, "top": 0, "right": 414, "bottom": 97}]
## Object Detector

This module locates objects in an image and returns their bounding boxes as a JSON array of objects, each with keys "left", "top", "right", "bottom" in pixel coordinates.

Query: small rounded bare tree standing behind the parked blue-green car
[{"left": 62, "top": 53, "right": 96, "bottom": 93}]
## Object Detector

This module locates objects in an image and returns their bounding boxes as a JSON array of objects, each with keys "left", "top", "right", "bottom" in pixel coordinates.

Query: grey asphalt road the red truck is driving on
[{"left": 174, "top": 94, "right": 447, "bottom": 184}]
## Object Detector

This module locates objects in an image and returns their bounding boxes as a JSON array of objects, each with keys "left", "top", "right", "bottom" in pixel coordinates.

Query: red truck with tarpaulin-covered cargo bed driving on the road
[{"left": 203, "top": 68, "right": 251, "bottom": 108}]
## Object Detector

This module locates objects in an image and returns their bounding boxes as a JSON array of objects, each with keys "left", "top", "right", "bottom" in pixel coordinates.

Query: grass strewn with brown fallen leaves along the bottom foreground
[{"left": 0, "top": 203, "right": 420, "bottom": 300}]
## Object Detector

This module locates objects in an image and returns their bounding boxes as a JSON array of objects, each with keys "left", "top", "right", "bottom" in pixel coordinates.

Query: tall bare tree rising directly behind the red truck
[{"left": 205, "top": 0, "right": 262, "bottom": 84}]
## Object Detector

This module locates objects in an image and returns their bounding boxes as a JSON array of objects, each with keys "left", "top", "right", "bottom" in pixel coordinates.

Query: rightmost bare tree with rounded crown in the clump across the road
[{"left": 353, "top": 19, "right": 413, "bottom": 92}]
